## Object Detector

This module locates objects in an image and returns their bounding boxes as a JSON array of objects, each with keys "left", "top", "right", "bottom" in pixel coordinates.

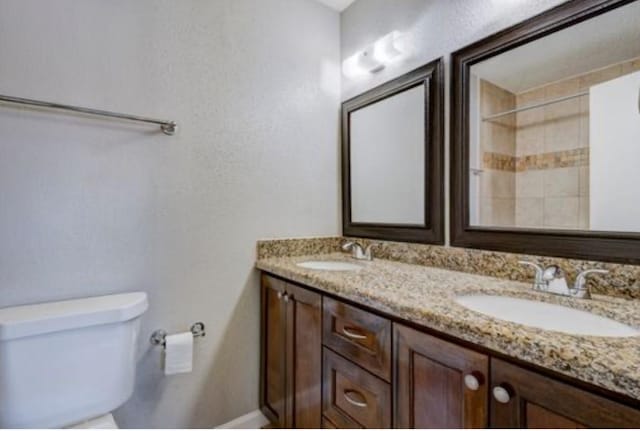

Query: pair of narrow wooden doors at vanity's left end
[{"left": 260, "top": 274, "right": 322, "bottom": 428}]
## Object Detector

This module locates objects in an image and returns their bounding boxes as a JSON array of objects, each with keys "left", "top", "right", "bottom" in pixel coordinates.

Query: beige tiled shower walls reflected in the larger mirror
[{"left": 480, "top": 59, "right": 640, "bottom": 229}]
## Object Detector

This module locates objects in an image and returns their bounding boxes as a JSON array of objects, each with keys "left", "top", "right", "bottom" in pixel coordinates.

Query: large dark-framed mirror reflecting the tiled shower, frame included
[{"left": 451, "top": 0, "right": 640, "bottom": 263}]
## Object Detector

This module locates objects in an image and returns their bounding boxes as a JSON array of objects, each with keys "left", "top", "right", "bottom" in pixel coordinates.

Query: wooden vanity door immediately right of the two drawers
[{"left": 393, "top": 324, "right": 489, "bottom": 428}]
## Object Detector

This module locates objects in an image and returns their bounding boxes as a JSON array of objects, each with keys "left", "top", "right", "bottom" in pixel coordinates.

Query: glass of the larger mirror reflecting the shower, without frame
[{"left": 468, "top": 1, "right": 640, "bottom": 232}]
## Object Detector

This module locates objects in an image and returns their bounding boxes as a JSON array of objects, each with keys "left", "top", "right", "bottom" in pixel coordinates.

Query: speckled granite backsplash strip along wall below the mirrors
[{"left": 257, "top": 237, "right": 640, "bottom": 299}]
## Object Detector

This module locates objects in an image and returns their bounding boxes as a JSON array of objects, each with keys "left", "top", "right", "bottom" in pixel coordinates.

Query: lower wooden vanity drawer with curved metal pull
[{"left": 322, "top": 347, "right": 391, "bottom": 428}]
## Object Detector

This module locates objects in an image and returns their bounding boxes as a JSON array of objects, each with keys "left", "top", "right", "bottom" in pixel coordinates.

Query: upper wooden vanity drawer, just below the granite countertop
[{"left": 322, "top": 298, "right": 391, "bottom": 381}]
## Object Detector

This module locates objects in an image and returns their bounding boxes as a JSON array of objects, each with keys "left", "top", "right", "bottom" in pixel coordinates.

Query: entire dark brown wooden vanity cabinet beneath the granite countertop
[{"left": 260, "top": 274, "right": 640, "bottom": 428}]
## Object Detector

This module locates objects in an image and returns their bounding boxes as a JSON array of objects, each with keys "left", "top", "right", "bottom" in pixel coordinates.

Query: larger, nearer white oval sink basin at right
[{"left": 456, "top": 295, "right": 640, "bottom": 337}]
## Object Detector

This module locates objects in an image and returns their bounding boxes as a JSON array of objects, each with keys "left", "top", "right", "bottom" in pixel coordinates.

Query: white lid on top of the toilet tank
[{"left": 0, "top": 292, "right": 149, "bottom": 341}]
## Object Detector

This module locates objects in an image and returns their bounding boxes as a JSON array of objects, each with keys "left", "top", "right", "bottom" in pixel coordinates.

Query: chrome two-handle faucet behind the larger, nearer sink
[{"left": 519, "top": 261, "right": 609, "bottom": 299}]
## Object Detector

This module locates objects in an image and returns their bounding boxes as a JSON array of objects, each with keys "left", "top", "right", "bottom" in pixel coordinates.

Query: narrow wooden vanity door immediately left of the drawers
[{"left": 285, "top": 284, "right": 322, "bottom": 428}]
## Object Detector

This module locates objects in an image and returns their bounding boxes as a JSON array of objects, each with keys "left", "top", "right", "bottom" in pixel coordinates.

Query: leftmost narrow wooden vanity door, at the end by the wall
[{"left": 260, "top": 274, "right": 286, "bottom": 428}]
